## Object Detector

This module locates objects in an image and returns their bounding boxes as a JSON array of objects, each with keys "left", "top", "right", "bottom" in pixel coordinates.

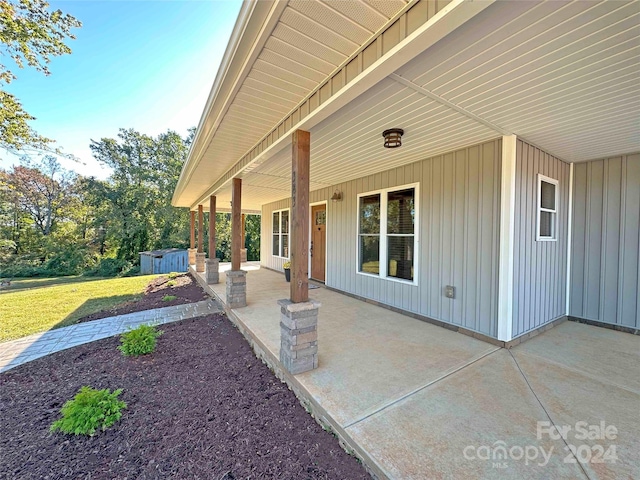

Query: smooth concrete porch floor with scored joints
[{"left": 195, "top": 262, "right": 640, "bottom": 479}]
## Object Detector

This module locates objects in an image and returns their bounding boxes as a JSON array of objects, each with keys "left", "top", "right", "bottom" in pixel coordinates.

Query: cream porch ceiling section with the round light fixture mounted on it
[{"left": 222, "top": 79, "right": 500, "bottom": 209}]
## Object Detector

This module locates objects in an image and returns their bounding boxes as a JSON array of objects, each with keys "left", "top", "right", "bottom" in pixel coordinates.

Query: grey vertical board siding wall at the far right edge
[{"left": 569, "top": 153, "right": 640, "bottom": 329}]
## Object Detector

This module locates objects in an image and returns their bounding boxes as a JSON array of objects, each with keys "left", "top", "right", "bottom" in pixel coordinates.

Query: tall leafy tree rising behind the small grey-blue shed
[{"left": 91, "top": 129, "right": 193, "bottom": 262}]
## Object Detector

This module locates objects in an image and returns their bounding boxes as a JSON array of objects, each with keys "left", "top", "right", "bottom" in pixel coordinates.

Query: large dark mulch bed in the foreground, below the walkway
[{"left": 0, "top": 314, "right": 369, "bottom": 480}]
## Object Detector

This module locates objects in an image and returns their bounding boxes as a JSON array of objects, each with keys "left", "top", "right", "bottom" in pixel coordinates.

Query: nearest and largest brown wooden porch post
[{"left": 289, "top": 130, "right": 311, "bottom": 303}]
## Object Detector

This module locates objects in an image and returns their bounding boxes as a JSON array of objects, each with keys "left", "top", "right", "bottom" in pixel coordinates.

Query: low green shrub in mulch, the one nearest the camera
[{"left": 51, "top": 386, "right": 127, "bottom": 436}]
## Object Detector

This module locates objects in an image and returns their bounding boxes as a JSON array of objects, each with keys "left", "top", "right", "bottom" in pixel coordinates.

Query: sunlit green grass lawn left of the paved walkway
[{"left": 0, "top": 275, "right": 155, "bottom": 342}]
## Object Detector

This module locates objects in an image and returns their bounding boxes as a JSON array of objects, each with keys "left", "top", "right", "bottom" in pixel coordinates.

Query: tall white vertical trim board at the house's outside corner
[{"left": 498, "top": 135, "right": 517, "bottom": 342}]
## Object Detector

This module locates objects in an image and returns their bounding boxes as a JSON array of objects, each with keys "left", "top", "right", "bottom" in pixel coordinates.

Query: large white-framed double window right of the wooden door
[{"left": 356, "top": 184, "right": 419, "bottom": 285}]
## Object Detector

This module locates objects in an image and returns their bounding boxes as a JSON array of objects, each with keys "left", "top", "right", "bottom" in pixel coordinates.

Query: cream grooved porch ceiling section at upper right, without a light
[{"left": 397, "top": 1, "right": 640, "bottom": 162}]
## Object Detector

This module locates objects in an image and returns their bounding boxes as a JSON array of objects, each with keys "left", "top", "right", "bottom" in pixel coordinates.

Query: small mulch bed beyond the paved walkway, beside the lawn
[{"left": 78, "top": 273, "right": 209, "bottom": 323}]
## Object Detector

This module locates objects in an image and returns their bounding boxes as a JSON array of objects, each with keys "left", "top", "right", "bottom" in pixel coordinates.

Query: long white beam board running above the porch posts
[{"left": 193, "top": 0, "right": 495, "bottom": 205}]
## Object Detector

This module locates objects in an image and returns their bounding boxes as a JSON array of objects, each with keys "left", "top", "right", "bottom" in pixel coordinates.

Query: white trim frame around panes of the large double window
[{"left": 355, "top": 182, "right": 420, "bottom": 286}]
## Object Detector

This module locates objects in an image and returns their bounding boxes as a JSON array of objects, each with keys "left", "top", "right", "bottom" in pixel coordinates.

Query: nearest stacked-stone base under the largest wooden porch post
[{"left": 278, "top": 299, "right": 320, "bottom": 375}]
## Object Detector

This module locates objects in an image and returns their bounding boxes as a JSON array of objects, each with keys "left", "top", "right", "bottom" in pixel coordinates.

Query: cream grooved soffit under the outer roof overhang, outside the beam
[{"left": 178, "top": 0, "right": 408, "bottom": 206}]
